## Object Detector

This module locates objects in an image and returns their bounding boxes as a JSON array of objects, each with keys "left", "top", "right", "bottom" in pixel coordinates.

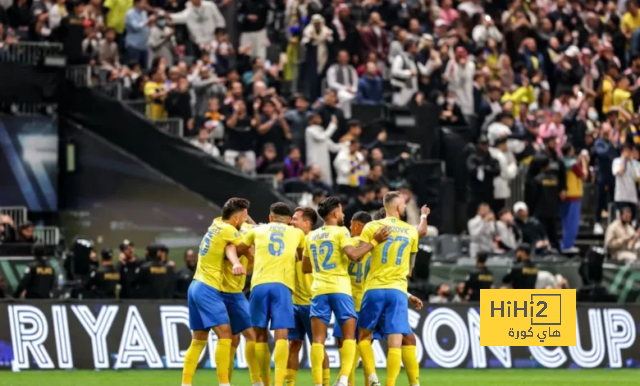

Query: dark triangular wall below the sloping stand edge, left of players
[{"left": 60, "top": 118, "right": 220, "bottom": 263}]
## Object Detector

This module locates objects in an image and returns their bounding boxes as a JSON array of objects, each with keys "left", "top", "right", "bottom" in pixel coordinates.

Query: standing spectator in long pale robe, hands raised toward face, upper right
[{"left": 444, "top": 47, "right": 475, "bottom": 117}]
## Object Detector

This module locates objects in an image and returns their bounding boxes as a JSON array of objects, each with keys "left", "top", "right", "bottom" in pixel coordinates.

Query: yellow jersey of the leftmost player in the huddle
[{"left": 193, "top": 217, "right": 242, "bottom": 291}]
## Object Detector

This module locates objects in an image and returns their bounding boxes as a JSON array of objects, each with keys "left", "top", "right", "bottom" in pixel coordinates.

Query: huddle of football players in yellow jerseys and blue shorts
[{"left": 182, "top": 192, "right": 429, "bottom": 386}]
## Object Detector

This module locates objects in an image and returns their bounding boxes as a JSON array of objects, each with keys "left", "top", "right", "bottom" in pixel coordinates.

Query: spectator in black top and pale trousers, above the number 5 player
[{"left": 224, "top": 100, "right": 258, "bottom": 169}]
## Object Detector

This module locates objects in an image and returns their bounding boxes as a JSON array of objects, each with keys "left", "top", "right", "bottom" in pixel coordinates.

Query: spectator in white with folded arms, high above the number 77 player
[{"left": 391, "top": 40, "right": 418, "bottom": 106}]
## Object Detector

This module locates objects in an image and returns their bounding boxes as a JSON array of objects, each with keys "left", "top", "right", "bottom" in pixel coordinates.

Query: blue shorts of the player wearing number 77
[{"left": 358, "top": 289, "right": 411, "bottom": 335}]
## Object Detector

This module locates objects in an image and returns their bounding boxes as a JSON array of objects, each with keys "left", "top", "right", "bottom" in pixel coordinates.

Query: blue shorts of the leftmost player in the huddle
[{"left": 187, "top": 280, "right": 229, "bottom": 331}]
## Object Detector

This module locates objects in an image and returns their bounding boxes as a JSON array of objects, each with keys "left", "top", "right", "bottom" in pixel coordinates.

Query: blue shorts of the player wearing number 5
[{"left": 249, "top": 283, "right": 296, "bottom": 330}]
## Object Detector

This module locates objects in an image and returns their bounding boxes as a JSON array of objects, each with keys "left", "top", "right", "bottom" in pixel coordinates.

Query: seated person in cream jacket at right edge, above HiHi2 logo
[{"left": 604, "top": 206, "right": 640, "bottom": 263}]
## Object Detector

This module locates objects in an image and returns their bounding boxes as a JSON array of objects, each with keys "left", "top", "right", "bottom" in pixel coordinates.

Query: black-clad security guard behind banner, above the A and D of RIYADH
[{"left": 137, "top": 244, "right": 175, "bottom": 299}]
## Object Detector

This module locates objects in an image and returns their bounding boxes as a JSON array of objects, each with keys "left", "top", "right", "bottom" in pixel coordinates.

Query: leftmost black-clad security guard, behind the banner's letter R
[{"left": 14, "top": 244, "right": 56, "bottom": 299}]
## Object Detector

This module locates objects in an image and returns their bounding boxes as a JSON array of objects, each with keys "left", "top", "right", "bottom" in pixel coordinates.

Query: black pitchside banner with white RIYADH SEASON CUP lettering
[{"left": 0, "top": 301, "right": 640, "bottom": 370}]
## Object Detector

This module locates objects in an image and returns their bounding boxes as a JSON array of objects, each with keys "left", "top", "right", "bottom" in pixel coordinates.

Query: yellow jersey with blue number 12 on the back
[{"left": 305, "top": 226, "right": 353, "bottom": 297}]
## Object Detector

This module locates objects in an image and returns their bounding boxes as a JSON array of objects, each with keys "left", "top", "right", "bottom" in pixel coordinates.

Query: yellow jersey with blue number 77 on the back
[{"left": 360, "top": 217, "right": 418, "bottom": 293}]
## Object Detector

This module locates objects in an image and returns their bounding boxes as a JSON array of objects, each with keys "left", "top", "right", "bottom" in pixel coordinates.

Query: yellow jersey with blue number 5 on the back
[{"left": 244, "top": 222, "right": 304, "bottom": 291}]
